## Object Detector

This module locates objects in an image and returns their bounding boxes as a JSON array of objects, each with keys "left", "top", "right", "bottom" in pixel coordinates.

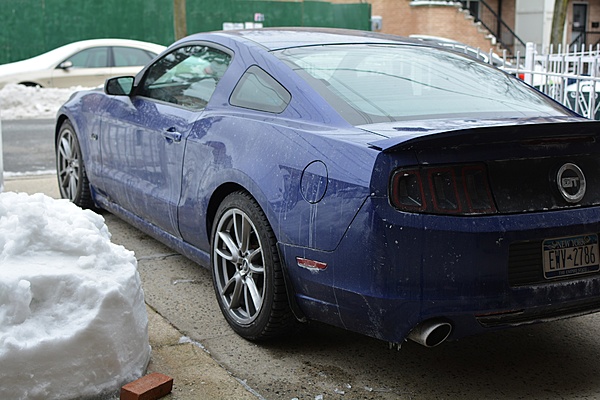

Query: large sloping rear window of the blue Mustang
[{"left": 275, "top": 45, "right": 569, "bottom": 125}]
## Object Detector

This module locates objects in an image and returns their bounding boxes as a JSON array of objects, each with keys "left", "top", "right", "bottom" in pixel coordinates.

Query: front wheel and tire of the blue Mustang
[{"left": 55, "top": 120, "right": 94, "bottom": 209}]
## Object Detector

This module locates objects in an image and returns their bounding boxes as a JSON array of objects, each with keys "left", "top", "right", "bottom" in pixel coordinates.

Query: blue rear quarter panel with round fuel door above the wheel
[{"left": 180, "top": 110, "right": 376, "bottom": 250}]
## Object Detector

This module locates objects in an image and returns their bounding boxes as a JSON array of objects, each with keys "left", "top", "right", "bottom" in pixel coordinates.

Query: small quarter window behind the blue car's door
[{"left": 229, "top": 65, "right": 292, "bottom": 114}]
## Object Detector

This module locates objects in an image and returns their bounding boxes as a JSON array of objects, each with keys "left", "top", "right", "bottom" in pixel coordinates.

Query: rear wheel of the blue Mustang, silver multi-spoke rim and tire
[{"left": 211, "top": 192, "right": 294, "bottom": 340}]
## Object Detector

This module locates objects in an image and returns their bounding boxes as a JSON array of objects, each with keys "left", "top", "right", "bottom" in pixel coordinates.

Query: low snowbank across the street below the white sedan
[{"left": 0, "top": 83, "right": 88, "bottom": 120}]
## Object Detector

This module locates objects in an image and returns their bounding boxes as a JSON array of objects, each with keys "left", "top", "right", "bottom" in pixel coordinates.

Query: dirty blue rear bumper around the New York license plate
[{"left": 286, "top": 198, "right": 600, "bottom": 342}]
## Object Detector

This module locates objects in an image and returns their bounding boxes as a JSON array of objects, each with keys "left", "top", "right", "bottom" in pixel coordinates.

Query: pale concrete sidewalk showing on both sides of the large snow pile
[{"left": 4, "top": 175, "right": 257, "bottom": 400}]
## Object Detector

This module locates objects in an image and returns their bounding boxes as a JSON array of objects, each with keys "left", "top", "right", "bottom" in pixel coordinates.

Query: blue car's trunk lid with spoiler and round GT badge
[{"left": 362, "top": 118, "right": 600, "bottom": 214}]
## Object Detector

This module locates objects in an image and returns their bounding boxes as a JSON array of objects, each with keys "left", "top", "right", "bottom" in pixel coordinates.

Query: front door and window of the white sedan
[{"left": 51, "top": 46, "right": 110, "bottom": 88}]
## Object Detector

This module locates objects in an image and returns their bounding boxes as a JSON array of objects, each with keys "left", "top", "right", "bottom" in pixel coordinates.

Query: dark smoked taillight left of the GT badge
[{"left": 390, "top": 164, "right": 496, "bottom": 215}]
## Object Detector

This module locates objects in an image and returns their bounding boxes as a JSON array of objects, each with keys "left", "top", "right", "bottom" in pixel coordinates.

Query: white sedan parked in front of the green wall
[{"left": 0, "top": 39, "right": 165, "bottom": 88}]
